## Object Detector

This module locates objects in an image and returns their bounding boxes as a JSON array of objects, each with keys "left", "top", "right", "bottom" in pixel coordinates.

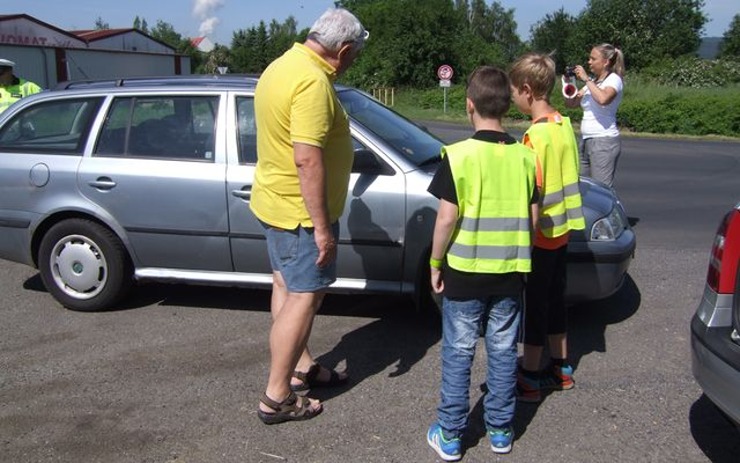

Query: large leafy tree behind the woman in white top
[{"left": 573, "top": 0, "right": 707, "bottom": 69}]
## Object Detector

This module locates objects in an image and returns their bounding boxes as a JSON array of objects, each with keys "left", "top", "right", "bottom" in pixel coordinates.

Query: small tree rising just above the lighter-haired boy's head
[{"left": 529, "top": 7, "right": 581, "bottom": 73}]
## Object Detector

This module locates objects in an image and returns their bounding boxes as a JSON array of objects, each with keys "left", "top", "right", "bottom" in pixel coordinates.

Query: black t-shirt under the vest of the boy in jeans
[{"left": 428, "top": 130, "right": 539, "bottom": 299}]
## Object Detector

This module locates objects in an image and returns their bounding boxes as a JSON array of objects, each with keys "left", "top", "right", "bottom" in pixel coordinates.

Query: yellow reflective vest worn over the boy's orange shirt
[{"left": 524, "top": 114, "right": 586, "bottom": 238}]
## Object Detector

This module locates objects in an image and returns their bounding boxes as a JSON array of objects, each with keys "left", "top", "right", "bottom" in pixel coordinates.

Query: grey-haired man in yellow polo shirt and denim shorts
[{"left": 250, "top": 8, "right": 369, "bottom": 424}]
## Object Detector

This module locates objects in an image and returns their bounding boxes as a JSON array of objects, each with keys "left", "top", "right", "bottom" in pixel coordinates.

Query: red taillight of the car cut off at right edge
[{"left": 707, "top": 209, "right": 740, "bottom": 294}]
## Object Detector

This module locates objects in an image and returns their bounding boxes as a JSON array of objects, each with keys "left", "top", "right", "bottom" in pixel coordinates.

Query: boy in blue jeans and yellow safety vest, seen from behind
[{"left": 427, "top": 66, "right": 538, "bottom": 461}]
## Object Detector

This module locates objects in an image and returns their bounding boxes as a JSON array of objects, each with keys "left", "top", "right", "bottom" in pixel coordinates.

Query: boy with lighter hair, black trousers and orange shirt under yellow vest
[{"left": 509, "top": 53, "right": 585, "bottom": 402}]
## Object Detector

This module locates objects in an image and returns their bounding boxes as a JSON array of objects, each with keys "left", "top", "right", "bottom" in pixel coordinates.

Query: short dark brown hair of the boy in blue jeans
[{"left": 467, "top": 66, "right": 511, "bottom": 119}]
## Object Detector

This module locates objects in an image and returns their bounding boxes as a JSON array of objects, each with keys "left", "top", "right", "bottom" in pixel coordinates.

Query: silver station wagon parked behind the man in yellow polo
[{"left": 0, "top": 75, "right": 635, "bottom": 311}]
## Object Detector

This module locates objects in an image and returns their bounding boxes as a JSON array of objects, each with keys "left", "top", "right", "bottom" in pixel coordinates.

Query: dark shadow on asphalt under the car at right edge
[{"left": 689, "top": 394, "right": 740, "bottom": 463}]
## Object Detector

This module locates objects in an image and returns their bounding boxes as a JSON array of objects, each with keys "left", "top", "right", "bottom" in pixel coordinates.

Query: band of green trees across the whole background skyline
[{"left": 111, "top": 0, "right": 724, "bottom": 88}]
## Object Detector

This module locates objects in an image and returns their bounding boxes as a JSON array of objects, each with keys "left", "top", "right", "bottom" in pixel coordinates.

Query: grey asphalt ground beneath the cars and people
[{"left": 0, "top": 124, "right": 740, "bottom": 463}]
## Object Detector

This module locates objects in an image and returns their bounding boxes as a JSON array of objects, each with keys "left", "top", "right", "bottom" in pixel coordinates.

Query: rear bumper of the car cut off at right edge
[{"left": 691, "top": 315, "right": 740, "bottom": 424}]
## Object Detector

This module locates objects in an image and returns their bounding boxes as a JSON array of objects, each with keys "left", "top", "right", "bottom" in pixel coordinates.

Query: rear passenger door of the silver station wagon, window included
[{"left": 79, "top": 92, "right": 233, "bottom": 271}]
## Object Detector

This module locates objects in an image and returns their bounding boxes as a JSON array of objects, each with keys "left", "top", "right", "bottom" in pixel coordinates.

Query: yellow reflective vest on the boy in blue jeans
[{"left": 442, "top": 139, "right": 536, "bottom": 273}]
